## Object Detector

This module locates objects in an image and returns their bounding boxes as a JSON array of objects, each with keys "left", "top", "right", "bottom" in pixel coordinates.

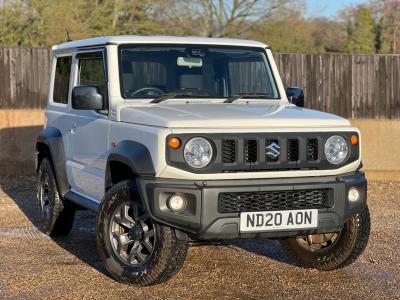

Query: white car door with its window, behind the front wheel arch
[{"left": 67, "top": 49, "right": 110, "bottom": 202}]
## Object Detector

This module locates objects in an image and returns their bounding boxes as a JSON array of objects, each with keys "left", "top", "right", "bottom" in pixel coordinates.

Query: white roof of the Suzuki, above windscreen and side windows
[{"left": 52, "top": 35, "right": 268, "bottom": 51}]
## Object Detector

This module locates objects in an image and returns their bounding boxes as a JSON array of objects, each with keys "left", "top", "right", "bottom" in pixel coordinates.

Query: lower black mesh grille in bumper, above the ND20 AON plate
[{"left": 218, "top": 189, "right": 330, "bottom": 213}]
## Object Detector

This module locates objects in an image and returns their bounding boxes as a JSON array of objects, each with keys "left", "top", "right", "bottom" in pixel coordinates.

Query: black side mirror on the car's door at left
[{"left": 72, "top": 86, "right": 104, "bottom": 110}]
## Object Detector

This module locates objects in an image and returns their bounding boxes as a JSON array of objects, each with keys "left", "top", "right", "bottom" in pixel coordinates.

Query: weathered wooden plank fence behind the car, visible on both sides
[{"left": 0, "top": 48, "right": 400, "bottom": 119}]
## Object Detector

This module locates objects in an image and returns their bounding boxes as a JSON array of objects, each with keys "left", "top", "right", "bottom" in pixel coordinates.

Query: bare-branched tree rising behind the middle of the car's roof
[{"left": 158, "top": 0, "right": 299, "bottom": 37}]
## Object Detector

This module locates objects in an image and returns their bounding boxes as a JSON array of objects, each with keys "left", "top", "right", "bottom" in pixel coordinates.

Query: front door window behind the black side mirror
[{"left": 78, "top": 53, "right": 106, "bottom": 97}]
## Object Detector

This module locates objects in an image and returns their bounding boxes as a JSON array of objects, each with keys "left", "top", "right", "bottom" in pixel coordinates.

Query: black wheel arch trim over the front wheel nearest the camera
[{"left": 105, "top": 140, "right": 156, "bottom": 190}]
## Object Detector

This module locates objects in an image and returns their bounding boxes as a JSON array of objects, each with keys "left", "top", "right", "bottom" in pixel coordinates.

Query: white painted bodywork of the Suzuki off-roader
[{"left": 46, "top": 36, "right": 361, "bottom": 201}]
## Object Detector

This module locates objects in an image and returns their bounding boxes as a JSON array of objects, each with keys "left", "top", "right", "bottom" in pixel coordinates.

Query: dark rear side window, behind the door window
[{"left": 53, "top": 56, "right": 72, "bottom": 104}]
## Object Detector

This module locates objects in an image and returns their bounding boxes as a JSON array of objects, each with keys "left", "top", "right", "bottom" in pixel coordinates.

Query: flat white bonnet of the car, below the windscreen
[{"left": 118, "top": 103, "right": 350, "bottom": 128}]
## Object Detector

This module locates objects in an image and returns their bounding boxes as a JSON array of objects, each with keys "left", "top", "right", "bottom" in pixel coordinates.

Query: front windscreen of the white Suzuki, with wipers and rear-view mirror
[{"left": 119, "top": 45, "right": 279, "bottom": 99}]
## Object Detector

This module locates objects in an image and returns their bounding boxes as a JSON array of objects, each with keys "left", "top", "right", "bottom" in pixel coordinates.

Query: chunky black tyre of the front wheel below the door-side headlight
[{"left": 96, "top": 180, "right": 188, "bottom": 286}]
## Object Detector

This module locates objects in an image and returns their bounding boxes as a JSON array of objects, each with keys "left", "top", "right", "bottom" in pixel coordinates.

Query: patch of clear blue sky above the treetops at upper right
[{"left": 306, "top": 0, "right": 368, "bottom": 17}]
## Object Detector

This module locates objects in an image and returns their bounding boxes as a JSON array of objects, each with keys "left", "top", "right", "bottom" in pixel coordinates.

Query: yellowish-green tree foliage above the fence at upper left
[{"left": 0, "top": 0, "right": 158, "bottom": 47}]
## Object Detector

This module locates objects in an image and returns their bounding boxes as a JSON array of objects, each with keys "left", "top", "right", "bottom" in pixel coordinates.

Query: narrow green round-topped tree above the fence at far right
[{"left": 346, "top": 5, "right": 376, "bottom": 53}]
